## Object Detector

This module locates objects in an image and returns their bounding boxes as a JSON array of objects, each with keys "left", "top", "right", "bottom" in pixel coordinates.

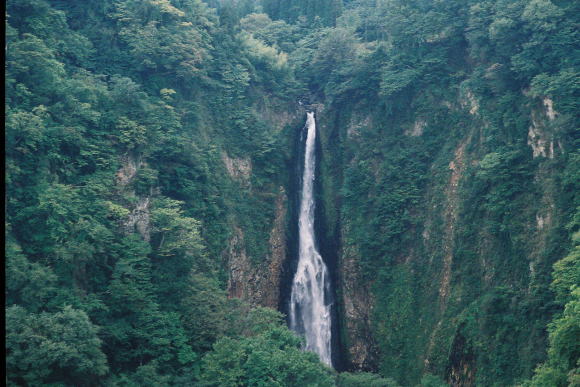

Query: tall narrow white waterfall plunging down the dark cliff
[{"left": 290, "top": 113, "right": 332, "bottom": 366}]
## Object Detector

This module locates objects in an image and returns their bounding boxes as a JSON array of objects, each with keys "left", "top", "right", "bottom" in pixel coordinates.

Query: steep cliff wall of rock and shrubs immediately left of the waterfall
[{"left": 222, "top": 106, "right": 304, "bottom": 310}]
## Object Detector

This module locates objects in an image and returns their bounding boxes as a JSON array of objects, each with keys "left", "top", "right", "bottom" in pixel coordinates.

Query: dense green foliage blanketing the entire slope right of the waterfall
[{"left": 312, "top": 0, "right": 580, "bottom": 386}]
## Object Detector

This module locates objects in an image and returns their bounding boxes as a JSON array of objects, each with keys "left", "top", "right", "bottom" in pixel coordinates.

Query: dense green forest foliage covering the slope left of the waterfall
[{"left": 5, "top": 0, "right": 314, "bottom": 386}]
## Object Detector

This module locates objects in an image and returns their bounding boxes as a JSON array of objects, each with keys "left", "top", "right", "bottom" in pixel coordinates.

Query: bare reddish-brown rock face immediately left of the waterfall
[{"left": 224, "top": 187, "right": 287, "bottom": 308}]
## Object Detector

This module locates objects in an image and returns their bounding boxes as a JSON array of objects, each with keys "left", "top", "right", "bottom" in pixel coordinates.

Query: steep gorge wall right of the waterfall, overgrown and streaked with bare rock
[{"left": 319, "top": 92, "right": 569, "bottom": 386}]
